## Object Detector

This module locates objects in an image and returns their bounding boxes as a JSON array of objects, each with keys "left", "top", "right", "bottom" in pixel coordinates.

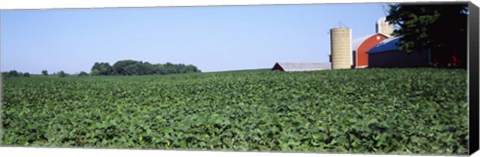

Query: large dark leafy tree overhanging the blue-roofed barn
[{"left": 386, "top": 3, "right": 468, "bottom": 66}]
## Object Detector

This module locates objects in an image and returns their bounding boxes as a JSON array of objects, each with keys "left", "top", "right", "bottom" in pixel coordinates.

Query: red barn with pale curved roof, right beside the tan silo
[{"left": 352, "top": 33, "right": 388, "bottom": 68}]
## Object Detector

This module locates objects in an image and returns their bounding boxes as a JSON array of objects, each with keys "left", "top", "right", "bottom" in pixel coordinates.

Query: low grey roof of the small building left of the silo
[{"left": 274, "top": 62, "right": 330, "bottom": 71}]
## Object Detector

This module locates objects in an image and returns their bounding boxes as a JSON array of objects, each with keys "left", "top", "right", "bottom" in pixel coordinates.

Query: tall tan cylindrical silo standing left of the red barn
[{"left": 330, "top": 28, "right": 353, "bottom": 69}]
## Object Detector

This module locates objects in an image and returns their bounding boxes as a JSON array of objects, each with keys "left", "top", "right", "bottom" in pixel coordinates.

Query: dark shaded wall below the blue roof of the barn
[{"left": 368, "top": 51, "right": 430, "bottom": 67}]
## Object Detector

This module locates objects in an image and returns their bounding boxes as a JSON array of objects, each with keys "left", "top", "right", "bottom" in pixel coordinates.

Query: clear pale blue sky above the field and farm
[{"left": 0, "top": 3, "right": 386, "bottom": 74}]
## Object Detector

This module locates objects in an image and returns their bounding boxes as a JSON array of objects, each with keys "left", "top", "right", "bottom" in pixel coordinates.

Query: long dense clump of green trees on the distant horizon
[{"left": 90, "top": 60, "right": 201, "bottom": 75}]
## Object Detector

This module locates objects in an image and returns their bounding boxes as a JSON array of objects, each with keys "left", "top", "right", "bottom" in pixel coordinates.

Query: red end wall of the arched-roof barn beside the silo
[{"left": 355, "top": 34, "right": 387, "bottom": 67}]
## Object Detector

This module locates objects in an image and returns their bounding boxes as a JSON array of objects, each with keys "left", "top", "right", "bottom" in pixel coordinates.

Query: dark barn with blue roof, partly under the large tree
[{"left": 368, "top": 37, "right": 432, "bottom": 67}]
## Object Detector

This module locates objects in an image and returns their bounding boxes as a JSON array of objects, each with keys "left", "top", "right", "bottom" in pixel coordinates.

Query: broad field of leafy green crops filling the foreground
[{"left": 1, "top": 68, "right": 468, "bottom": 154}]
